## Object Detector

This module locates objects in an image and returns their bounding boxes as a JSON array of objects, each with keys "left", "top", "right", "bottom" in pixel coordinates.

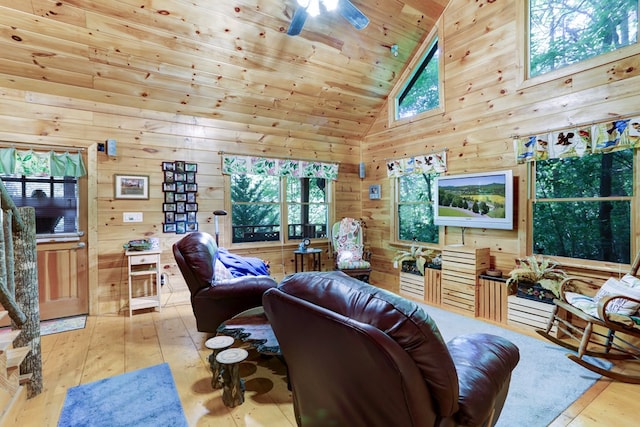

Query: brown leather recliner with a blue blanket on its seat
[{"left": 173, "top": 232, "right": 277, "bottom": 333}]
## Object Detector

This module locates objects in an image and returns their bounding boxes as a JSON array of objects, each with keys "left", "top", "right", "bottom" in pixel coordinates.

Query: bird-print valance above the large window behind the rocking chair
[{"left": 513, "top": 117, "right": 640, "bottom": 163}]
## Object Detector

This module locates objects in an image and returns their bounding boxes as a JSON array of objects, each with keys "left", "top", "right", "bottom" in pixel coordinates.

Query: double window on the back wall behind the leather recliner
[{"left": 230, "top": 174, "right": 329, "bottom": 243}]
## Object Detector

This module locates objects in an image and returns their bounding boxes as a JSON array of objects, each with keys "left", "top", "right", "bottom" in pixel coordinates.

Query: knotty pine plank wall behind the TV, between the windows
[{"left": 362, "top": 0, "right": 640, "bottom": 288}]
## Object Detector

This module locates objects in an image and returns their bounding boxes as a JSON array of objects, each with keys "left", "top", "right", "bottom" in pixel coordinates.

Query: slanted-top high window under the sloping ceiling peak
[{"left": 395, "top": 38, "right": 440, "bottom": 120}]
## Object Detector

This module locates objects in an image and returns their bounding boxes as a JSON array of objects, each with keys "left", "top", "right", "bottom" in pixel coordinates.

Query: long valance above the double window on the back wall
[{"left": 222, "top": 154, "right": 338, "bottom": 180}]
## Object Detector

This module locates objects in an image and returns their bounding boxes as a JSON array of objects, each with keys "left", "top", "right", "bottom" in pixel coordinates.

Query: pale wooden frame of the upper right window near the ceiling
[{"left": 516, "top": 0, "right": 640, "bottom": 89}]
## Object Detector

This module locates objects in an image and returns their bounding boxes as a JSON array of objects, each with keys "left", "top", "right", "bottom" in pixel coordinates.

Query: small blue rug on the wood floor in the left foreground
[{"left": 58, "top": 363, "right": 188, "bottom": 427}]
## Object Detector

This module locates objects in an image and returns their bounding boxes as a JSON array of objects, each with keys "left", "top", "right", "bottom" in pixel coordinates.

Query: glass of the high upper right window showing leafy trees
[{"left": 528, "top": 0, "right": 638, "bottom": 77}]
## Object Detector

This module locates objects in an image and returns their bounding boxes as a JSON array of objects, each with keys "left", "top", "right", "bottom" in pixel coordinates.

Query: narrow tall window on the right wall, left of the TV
[{"left": 396, "top": 174, "right": 439, "bottom": 243}]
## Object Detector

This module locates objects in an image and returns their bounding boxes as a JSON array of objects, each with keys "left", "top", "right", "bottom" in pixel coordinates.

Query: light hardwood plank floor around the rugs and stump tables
[{"left": 13, "top": 298, "right": 640, "bottom": 427}]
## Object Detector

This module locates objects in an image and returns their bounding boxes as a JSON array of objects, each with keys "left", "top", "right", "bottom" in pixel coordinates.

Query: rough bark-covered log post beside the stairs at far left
[{"left": 8, "top": 207, "right": 42, "bottom": 398}]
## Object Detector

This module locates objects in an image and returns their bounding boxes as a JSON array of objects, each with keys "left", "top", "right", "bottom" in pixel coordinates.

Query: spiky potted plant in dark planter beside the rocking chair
[{"left": 507, "top": 255, "right": 567, "bottom": 303}]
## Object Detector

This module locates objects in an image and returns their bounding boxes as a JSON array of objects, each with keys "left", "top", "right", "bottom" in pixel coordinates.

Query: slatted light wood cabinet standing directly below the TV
[{"left": 442, "top": 245, "right": 490, "bottom": 317}]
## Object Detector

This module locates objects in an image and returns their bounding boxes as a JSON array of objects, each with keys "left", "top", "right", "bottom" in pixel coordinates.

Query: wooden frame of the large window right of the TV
[{"left": 526, "top": 149, "right": 640, "bottom": 264}]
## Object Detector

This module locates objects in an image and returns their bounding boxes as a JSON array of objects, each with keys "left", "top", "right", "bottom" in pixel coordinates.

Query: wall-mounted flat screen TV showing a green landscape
[{"left": 434, "top": 170, "right": 513, "bottom": 230}]
